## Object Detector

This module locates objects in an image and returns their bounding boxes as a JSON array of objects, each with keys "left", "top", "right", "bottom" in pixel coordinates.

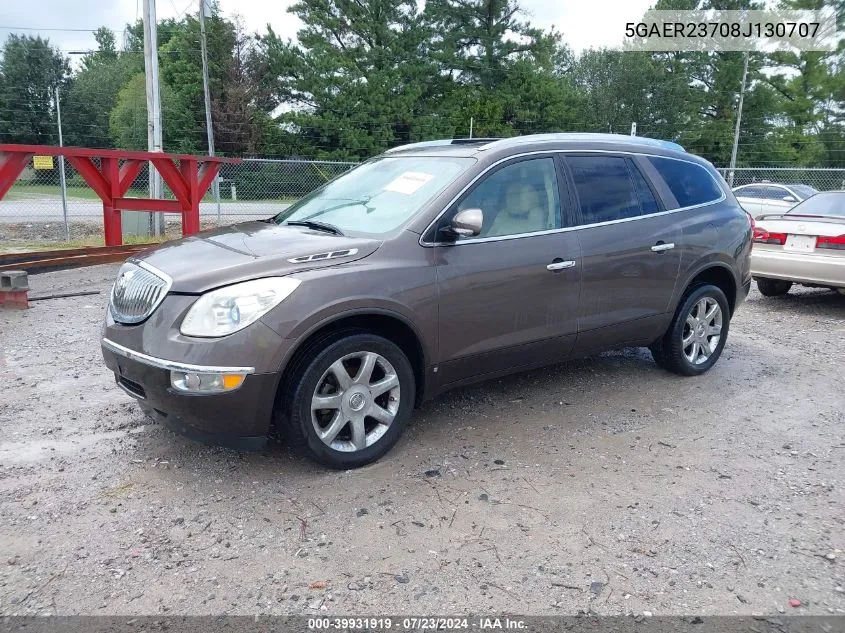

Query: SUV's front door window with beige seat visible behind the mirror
[{"left": 458, "top": 158, "right": 561, "bottom": 239}]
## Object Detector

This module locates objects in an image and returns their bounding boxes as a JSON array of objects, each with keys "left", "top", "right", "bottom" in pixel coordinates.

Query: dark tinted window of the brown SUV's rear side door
[{"left": 566, "top": 156, "right": 657, "bottom": 224}]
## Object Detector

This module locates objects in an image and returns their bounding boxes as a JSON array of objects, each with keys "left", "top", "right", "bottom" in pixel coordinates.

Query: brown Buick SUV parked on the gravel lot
[{"left": 102, "top": 134, "right": 751, "bottom": 468}]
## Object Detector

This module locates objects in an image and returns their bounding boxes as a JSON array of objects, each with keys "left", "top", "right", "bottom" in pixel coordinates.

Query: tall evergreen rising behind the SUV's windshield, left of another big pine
[{"left": 262, "top": 0, "right": 451, "bottom": 158}]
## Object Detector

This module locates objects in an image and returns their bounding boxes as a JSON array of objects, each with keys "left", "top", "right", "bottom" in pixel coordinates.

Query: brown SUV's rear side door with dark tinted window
[{"left": 564, "top": 153, "right": 681, "bottom": 354}]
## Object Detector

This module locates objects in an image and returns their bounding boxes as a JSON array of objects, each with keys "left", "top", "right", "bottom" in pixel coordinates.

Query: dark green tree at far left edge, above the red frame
[{"left": 0, "top": 33, "right": 70, "bottom": 145}]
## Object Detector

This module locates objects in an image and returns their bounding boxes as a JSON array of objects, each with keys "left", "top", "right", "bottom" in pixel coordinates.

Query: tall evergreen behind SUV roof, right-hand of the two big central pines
[{"left": 424, "top": 0, "right": 577, "bottom": 136}]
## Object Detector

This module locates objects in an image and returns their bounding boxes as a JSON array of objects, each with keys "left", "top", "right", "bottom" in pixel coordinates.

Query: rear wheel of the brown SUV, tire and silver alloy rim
[{"left": 649, "top": 284, "right": 730, "bottom": 376}]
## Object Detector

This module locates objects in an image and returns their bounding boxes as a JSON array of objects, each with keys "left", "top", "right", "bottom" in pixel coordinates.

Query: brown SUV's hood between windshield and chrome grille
[{"left": 132, "top": 222, "right": 381, "bottom": 294}]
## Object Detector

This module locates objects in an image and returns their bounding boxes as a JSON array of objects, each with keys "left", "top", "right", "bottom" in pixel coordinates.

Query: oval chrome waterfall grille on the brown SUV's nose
[{"left": 109, "top": 262, "right": 171, "bottom": 323}]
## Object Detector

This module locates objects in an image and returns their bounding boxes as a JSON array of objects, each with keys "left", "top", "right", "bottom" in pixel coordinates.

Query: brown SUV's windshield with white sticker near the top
[{"left": 274, "top": 156, "right": 475, "bottom": 237}]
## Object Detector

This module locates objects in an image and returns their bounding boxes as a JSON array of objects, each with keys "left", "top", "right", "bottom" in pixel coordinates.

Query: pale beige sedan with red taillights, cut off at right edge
[{"left": 751, "top": 191, "right": 845, "bottom": 297}]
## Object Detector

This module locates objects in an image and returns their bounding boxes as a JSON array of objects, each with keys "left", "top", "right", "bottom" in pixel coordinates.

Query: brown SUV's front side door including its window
[{"left": 428, "top": 155, "right": 581, "bottom": 386}]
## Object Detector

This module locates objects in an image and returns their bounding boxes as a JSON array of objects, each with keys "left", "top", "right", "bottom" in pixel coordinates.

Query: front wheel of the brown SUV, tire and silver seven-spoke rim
[{"left": 284, "top": 331, "right": 416, "bottom": 469}]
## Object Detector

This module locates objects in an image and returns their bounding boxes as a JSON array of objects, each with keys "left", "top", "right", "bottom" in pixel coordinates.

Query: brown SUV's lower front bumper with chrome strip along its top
[{"left": 102, "top": 338, "right": 278, "bottom": 450}]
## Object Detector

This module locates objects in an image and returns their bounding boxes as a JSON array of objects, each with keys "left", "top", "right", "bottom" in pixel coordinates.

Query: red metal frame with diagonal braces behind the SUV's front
[{"left": 0, "top": 144, "right": 240, "bottom": 246}]
